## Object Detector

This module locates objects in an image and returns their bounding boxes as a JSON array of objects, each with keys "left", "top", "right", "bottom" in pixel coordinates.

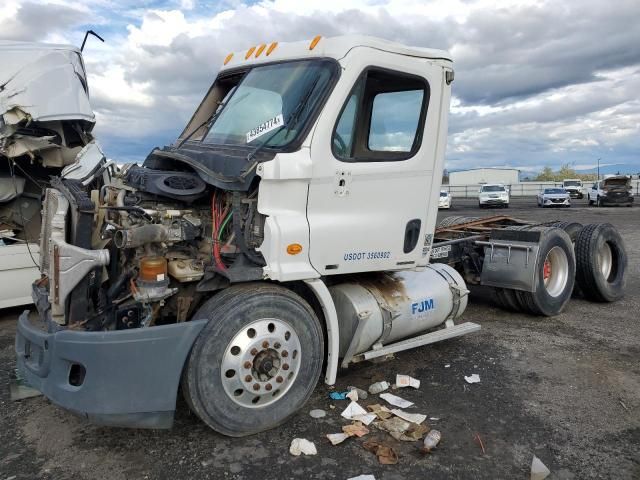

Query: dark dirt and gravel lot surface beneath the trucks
[{"left": 0, "top": 199, "right": 640, "bottom": 480}]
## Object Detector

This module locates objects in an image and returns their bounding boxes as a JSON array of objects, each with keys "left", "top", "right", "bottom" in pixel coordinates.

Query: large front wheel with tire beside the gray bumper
[{"left": 182, "top": 283, "right": 324, "bottom": 437}]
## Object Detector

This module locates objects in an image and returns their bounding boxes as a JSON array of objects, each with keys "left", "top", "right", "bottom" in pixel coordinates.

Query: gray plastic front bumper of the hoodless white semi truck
[{"left": 16, "top": 311, "right": 206, "bottom": 428}]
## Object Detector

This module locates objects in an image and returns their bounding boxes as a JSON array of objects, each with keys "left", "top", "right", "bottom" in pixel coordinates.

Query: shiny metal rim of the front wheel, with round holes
[{"left": 220, "top": 318, "right": 301, "bottom": 408}]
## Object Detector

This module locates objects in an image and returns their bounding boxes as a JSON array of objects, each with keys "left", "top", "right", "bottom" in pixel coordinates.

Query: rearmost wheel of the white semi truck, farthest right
[{"left": 576, "top": 223, "right": 628, "bottom": 302}]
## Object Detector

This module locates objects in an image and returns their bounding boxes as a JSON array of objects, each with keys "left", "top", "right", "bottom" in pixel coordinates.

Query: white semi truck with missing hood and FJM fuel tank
[{"left": 11, "top": 36, "right": 626, "bottom": 436}]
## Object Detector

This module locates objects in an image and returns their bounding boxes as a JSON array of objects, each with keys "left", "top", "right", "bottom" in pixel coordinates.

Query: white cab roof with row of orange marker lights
[{"left": 221, "top": 35, "right": 452, "bottom": 71}]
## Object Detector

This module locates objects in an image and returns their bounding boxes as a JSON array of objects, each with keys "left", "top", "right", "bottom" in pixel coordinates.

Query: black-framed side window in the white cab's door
[{"left": 332, "top": 68, "right": 429, "bottom": 162}]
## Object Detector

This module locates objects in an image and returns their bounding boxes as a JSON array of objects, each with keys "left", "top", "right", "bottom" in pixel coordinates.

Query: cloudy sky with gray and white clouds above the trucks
[{"left": 0, "top": 0, "right": 640, "bottom": 170}]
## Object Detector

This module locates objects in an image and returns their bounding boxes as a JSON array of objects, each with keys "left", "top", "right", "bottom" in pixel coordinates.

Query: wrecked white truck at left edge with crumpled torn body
[{"left": 0, "top": 41, "right": 95, "bottom": 308}]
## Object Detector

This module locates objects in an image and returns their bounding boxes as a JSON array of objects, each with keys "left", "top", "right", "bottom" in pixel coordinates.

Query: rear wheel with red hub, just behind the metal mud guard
[{"left": 515, "top": 227, "right": 576, "bottom": 317}]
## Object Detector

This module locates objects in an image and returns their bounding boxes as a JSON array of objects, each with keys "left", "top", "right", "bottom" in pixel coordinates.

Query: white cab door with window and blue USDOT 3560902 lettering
[{"left": 307, "top": 47, "right": 450, "bottom": 275}]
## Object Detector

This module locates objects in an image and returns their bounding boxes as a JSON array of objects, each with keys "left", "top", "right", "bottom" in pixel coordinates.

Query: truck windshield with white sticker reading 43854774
[{"left": 203, "top": 59, "right": 335, "bottom": 147}]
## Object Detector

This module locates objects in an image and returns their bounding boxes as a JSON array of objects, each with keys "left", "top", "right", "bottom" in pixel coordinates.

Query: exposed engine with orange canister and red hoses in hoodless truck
[{"left": 49, "top": 164, "right": 264, "bottom": 330}]
